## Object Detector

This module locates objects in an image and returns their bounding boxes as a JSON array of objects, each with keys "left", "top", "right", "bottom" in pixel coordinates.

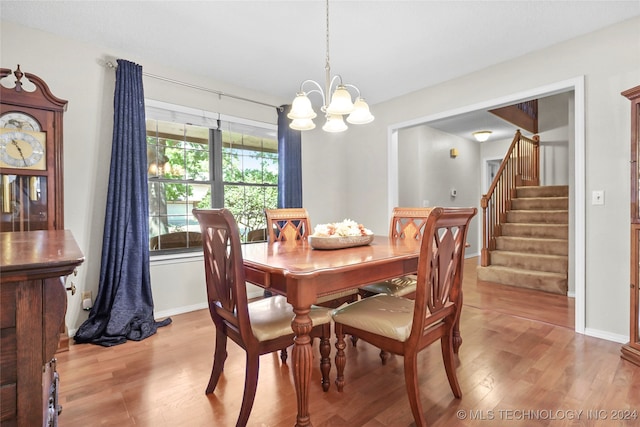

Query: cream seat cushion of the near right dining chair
[{"left": 333, "top": 294, "right": 414, "bottom": 342}]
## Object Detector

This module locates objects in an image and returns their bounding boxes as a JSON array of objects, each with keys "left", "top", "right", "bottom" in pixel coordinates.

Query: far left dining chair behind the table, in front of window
[{"left": 264, "top": 208, "right": 359, "bottom": 308}]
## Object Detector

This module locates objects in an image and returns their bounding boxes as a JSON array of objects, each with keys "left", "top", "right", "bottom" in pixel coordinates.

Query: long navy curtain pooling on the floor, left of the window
[{"left": 74, "top": 59, "right": 171, "bottom": 346}]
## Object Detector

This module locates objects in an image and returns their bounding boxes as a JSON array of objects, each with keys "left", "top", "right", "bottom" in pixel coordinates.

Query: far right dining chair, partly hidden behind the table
[{"left": 360, "top": 207, "right": 432, "bottom": 300}]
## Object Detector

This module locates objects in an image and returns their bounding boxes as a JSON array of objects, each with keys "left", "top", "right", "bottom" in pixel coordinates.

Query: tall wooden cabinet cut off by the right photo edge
[{"left": 621, "top": 86, "right": 640, "bottom": 365}]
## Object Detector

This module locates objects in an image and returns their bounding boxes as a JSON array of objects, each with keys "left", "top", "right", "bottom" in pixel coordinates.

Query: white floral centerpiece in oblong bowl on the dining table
[{"left": 309, "top": 219, "right": 373, "bottom": 249}]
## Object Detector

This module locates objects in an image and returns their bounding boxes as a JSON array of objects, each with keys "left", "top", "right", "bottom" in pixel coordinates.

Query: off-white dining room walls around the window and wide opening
[{"left": 0, "top": 18, "right": 640, "bottom": 339}]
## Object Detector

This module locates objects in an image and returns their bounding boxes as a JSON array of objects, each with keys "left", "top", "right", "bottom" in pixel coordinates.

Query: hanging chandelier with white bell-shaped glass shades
[{"left": 287, "top": 0, "right": 373, "bottom": 132}]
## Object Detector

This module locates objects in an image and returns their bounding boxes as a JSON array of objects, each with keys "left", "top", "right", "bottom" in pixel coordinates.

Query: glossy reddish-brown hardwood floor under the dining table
[{"left": 58, "top": 258, "right": 640, "bottom": 427}]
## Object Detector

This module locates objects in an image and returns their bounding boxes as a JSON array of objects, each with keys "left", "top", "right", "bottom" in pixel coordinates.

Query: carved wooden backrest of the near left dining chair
[{"left": 193, "top": 209, "right": 255, "bottom": 343}]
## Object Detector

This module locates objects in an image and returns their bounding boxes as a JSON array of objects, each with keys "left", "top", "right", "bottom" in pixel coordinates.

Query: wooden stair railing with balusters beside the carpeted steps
[{"left": 480, "top": 130, "right": 540, "bottom": 267}]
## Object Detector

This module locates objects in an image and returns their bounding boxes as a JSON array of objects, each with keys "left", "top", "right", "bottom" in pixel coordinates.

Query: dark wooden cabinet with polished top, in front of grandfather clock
[{"left": 0, "top": 230, "right": 84, "bottom": 427}]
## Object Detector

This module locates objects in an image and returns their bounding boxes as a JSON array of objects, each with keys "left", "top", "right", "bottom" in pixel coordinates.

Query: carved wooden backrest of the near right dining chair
[{"left": 409, "top": 208, "right": 477, "bottom": 346}]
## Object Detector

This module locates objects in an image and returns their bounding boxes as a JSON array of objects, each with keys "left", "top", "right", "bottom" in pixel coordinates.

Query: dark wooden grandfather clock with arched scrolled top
[{"left": 0, "top": 65, "right": 67, "bottom": 231}]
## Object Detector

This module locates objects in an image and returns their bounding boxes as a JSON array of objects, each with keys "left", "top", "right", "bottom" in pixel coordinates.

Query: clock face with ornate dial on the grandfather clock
[{"left": 0, "top": 130, "right": 46, "bottom": 170}]
